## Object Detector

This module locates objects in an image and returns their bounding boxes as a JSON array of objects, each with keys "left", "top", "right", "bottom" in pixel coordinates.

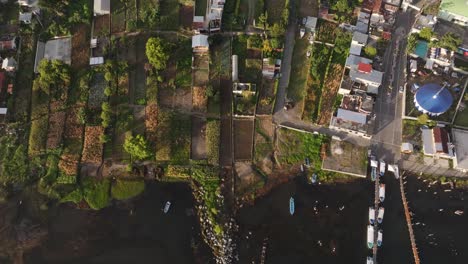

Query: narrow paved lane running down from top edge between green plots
[{"left": 273, "top": 0, "right": 297, "bottom": 113}]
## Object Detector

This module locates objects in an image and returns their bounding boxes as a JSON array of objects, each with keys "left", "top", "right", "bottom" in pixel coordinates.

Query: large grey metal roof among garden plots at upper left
[{"left": 34, "top": 37, "right": 71, "bottom": 73}]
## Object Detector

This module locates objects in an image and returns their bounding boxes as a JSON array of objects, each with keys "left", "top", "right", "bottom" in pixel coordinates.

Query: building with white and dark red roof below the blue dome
[{"left": 421, "top": 127, "right": 455, "bottom": 159}]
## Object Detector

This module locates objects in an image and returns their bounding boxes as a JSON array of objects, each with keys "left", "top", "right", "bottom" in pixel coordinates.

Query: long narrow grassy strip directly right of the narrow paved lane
[{"left": 288, "top": 37, "right": 310, "bottom": 102}]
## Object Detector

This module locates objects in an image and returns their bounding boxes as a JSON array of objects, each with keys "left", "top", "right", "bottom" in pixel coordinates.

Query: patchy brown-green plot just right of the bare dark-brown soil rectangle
[{"left": 254, "top": 116, "right": 275, "bottom": 174}]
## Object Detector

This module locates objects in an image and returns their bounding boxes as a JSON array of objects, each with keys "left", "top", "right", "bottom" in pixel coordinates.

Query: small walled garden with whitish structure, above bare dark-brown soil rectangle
[{"left": 232, "top": 82, "right": 257, "bottom": 116}]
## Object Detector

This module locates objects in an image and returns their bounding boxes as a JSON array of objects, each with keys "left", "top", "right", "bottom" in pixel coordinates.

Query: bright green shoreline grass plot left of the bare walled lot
[{"left": 277, "top": 128, "right": 328, "bottom": 170}]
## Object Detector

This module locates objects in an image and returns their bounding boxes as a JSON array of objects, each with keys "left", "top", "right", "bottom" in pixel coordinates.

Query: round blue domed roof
[{"left": 414, "top": 83, "right": 453, "bottom": 115}]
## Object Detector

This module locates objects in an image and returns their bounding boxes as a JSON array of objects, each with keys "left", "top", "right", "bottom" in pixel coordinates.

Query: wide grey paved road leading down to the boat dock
[{"left": 372, "top": 12, "right": 414, "bottom": 163}]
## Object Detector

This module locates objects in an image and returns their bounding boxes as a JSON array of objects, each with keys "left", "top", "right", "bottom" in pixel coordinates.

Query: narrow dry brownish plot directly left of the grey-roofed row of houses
[{"left": 317, "top": 64, "right": 343, "bottom": 125}]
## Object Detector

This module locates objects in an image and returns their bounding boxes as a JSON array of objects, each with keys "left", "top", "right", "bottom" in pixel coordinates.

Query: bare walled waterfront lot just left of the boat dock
[{"left": 322, "top": 139, "right": 367, "bottom": 177}]
